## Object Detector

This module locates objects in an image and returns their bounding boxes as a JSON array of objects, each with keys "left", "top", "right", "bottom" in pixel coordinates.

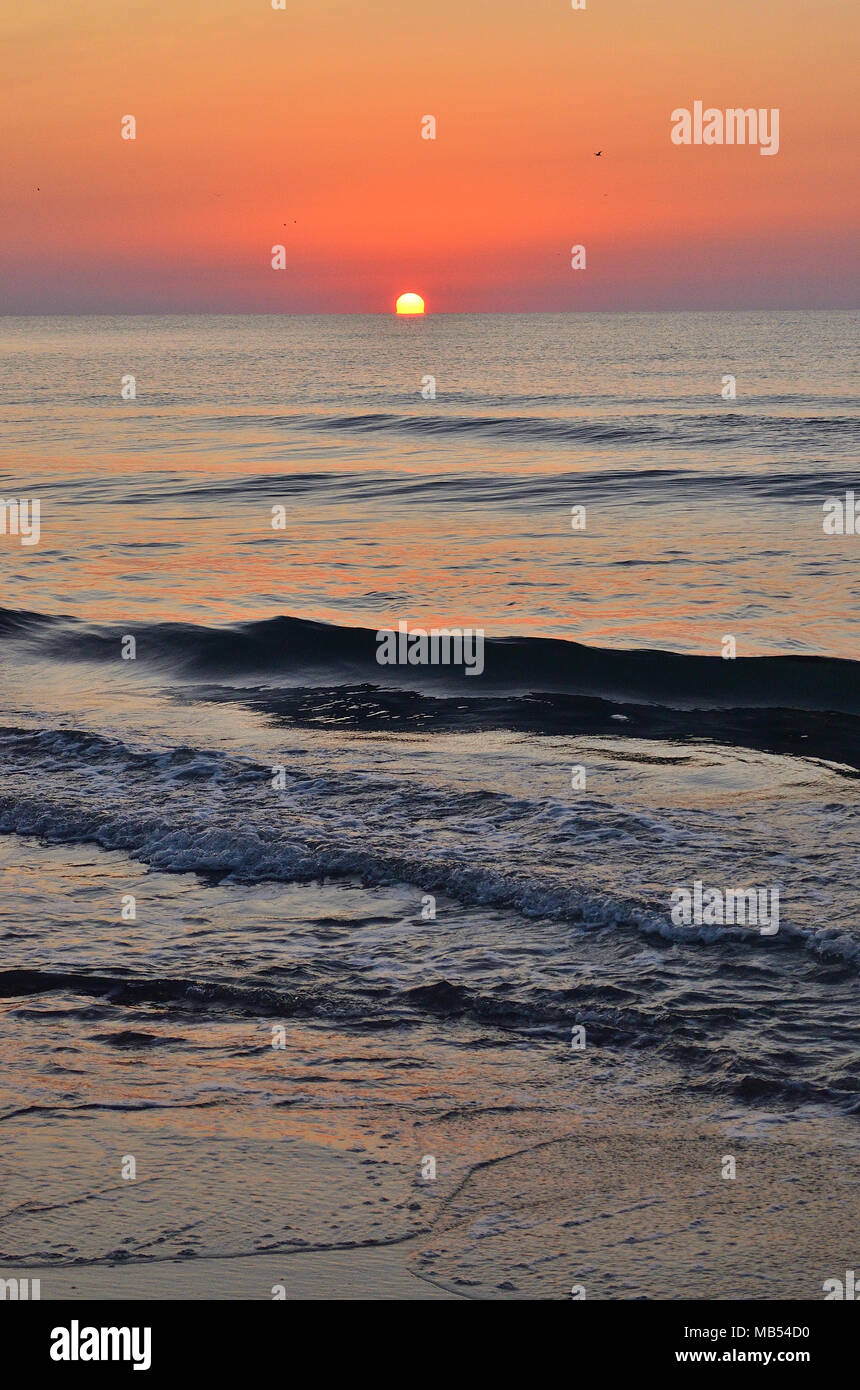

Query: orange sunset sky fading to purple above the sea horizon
[{"left": 0, "top": 0, "right": 860, "bottom": 313}]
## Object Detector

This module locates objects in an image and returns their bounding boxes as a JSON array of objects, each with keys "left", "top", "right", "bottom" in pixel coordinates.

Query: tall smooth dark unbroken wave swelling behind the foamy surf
[{"left": 0, "top": 609, "right": 860, "bottom": 722}]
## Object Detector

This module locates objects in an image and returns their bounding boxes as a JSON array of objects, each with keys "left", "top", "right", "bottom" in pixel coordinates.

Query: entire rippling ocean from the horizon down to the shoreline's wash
[{"left": 0, "top": 311, "right": 860, "bottom": 1298}]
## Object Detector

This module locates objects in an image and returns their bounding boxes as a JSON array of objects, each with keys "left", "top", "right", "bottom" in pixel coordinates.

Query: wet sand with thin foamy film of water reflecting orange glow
[{"left": 0, "top": 1067, "right": 860, "bottom": 1300}]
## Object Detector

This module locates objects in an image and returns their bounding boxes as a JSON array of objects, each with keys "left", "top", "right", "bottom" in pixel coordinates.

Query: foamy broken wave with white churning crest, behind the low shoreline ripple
[{"left": 0, "top": 728, "right": 860, "bottom": 969}]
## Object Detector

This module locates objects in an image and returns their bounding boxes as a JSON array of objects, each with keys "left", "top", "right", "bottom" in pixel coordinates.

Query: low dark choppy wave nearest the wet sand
[{"left": 0, "top": 967, "right": 860, "bottom": 1119}]
